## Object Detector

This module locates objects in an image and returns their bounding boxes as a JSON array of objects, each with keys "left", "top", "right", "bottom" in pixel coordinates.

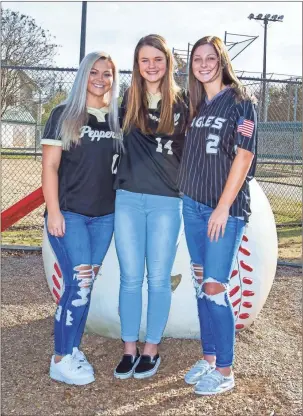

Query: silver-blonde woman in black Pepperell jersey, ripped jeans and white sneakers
[{"left": 42, "top": 52, "right": 120, "bottom": 385}]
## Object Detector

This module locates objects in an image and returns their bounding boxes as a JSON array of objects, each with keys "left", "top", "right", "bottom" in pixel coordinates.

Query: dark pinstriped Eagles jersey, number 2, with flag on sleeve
[{"left": 177, "top": 87, "right": 257, "bottom": 221}]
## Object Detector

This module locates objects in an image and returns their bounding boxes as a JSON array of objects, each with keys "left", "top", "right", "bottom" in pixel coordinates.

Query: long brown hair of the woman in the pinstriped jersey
[{"left": 188, "top": 36, "right": 253, "bottom": 121}]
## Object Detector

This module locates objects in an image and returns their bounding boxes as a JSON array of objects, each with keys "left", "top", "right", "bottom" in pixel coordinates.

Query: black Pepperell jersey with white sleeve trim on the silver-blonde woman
[{"left": 41, "top": 105, "right": 119, "bottom": 217}]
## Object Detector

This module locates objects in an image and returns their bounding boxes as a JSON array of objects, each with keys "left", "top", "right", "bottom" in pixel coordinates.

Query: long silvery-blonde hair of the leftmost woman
[{"left": 56, "top": 52, "right": 121, "bottom": 150}]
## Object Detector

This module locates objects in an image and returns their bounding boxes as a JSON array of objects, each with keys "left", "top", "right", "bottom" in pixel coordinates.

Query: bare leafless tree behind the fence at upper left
[{"left": 1, "top": 9, "right": 58, "bottom": 116}]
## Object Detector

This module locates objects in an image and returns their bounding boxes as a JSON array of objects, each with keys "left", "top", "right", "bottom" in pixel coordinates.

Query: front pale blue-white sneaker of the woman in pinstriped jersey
[{"left": 195, "top": 370, "right": 235, "bottom": 395}]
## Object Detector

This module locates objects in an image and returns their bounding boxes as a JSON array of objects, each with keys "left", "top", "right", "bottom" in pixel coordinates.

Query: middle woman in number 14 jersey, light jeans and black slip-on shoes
[{"left": 114, "top": 35, "right": 187, "bottom": 379}]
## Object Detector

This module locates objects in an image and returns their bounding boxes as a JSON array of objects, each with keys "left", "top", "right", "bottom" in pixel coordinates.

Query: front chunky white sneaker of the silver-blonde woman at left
[{"left": 49, "top": 354, "right": 95, "bottom": 386}]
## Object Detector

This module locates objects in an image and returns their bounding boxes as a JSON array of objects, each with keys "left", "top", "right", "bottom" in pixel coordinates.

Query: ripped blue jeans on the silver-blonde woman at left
[{"left": 45, "top": 211, "right": 114, "bottom": 355}]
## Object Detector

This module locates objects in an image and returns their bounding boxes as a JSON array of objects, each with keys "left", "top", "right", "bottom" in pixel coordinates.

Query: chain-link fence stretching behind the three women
[{"left": 1, "top": 66, "right": 302, "bottom": 260}]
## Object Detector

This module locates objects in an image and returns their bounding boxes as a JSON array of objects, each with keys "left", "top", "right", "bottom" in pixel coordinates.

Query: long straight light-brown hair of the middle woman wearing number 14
[{"left": 123, "top": 35, "right": 180, "bottom": 134}]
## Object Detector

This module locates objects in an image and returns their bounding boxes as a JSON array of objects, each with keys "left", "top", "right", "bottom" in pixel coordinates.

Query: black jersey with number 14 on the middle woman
[{"left": 114, "top": 91, "right": 188, "bottom": 197}]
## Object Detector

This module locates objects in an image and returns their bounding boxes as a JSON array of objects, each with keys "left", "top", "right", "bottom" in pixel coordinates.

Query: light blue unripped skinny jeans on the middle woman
[{"left": 114, "top": 189, "right": 182, "bottom": 344}]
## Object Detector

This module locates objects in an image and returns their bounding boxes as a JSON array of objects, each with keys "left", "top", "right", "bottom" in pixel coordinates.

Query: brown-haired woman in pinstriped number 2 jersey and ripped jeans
[{"left": 178, "top": 36, "right": 257, "bottom": 395}]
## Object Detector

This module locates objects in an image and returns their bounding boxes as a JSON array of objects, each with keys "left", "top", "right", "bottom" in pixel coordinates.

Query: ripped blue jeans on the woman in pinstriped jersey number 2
[{"left": 183, "top": 195, "right": 245, "bottom": 368}]
